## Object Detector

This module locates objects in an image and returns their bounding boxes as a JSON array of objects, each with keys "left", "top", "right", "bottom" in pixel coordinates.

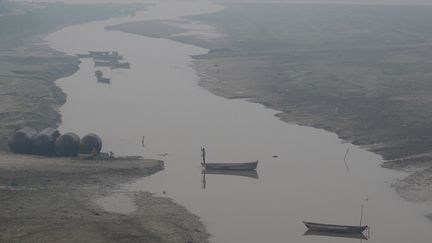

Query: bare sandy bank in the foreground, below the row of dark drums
[{"left": 0, "top": 153, "right": 208, "bottom": 242}]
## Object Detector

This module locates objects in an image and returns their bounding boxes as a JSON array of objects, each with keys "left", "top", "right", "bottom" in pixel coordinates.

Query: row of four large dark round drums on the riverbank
[{"left": 8, "top": 127, "right": 102, "bottom": 157}]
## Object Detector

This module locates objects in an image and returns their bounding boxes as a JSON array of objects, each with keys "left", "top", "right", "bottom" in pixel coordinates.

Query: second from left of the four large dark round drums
[{"left": 32, "top": 128, "right": 60, "bottom": 156}]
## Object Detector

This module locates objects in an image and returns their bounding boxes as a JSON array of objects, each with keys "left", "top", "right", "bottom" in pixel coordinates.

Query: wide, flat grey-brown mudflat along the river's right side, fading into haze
[{"left": 108, "top": 3, "right": 432, "bottom": 207}]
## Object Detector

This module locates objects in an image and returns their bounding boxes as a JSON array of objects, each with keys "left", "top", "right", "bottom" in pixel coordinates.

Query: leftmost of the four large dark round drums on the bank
[{"left": 8, "top": 127, "right": 37, "bottom": 154}]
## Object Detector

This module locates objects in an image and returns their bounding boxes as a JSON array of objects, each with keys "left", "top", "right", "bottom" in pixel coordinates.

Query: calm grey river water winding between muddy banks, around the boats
[{"left": 47, "top": 2, "right": 432, "bottom": 243}]
